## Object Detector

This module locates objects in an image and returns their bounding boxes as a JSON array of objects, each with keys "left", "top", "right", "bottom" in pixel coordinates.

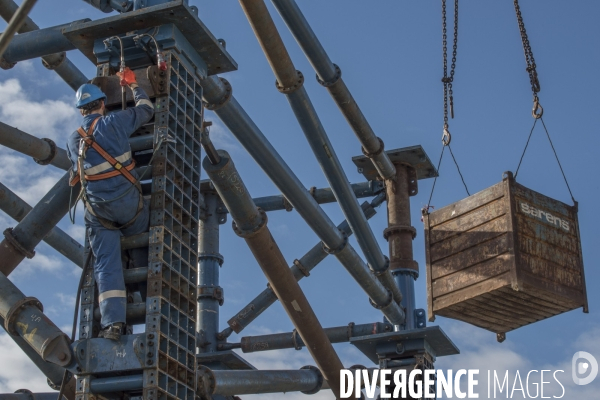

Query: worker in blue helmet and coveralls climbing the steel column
[{"left": 67, "top": 68, "right": 154, "bottom": 340}]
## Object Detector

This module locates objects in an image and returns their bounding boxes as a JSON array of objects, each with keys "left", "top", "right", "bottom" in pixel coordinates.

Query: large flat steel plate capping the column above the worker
[{"left": 63, "top": 0, "right": 237, "bottom": 75}]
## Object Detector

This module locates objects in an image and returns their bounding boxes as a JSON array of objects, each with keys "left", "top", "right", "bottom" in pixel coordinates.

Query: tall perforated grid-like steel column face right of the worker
[{"left": 143, "top": 51, "right": 203, "bottom": 400}]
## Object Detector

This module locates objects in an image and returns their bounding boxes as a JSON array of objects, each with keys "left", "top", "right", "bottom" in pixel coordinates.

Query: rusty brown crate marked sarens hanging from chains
[{"left": 424, "top": 172, "right": 588, "bottom": 341}]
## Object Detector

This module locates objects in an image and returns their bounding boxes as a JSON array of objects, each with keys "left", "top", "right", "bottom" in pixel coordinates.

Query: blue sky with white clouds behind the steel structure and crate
[{"left": 0, "top": 0, "right": 600, "bottom": 399}]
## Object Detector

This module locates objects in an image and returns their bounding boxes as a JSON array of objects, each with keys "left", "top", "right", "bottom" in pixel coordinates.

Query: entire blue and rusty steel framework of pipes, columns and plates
[{"left": 0, "top": 0, "right": 458, "bottom": 400}]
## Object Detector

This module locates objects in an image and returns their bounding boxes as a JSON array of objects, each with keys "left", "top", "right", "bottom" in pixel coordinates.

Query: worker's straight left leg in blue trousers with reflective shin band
[{"left": 85, "top": 212, "right": 127, "bottom": 328}]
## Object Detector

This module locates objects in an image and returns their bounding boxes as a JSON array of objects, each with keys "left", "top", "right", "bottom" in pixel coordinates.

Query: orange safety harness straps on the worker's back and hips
[{"left": 69, "top": 117, "right": 144, "bottom": 230}]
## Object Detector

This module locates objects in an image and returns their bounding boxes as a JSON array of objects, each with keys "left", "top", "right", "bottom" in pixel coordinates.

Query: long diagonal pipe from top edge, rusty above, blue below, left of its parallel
[{"left": 239, "top": 0, "right": 402, "bottom": 303}]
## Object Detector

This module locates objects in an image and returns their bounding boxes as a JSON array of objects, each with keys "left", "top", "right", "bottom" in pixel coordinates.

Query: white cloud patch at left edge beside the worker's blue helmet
[{"left": 0, "top": 79, "right": 81, "bottom": 142}]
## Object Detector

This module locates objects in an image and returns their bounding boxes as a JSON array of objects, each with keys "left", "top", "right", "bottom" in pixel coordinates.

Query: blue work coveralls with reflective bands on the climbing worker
[{"left": 67, "top": 87, "right": 154, "bottom": 328}]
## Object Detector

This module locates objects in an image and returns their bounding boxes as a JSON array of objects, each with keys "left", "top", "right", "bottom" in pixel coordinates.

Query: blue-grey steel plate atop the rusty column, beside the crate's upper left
[{"left": 352, "top": 145, "right": 438, "bottom": 181}]
